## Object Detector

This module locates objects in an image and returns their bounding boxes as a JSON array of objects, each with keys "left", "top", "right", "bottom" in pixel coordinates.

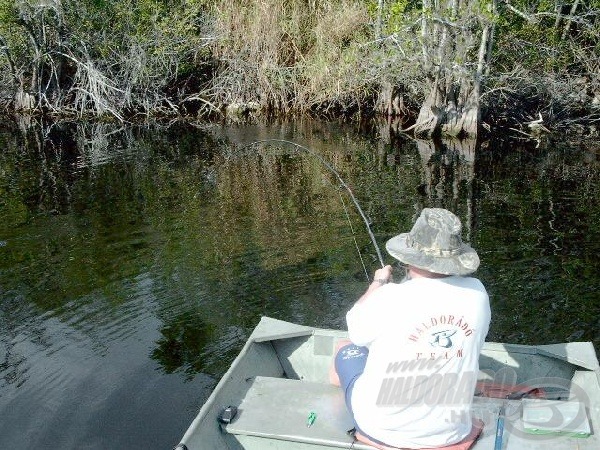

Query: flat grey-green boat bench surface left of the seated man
[{"left": 223, "top": 377, "right": 372, "bottom": 450}]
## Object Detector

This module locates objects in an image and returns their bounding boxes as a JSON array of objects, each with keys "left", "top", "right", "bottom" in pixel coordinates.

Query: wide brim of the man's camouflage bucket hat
[{"left": 385, "top": 233, "right": 479, "bottom": 275}]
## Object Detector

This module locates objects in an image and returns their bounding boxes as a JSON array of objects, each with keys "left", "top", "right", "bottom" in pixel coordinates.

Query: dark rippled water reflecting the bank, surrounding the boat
[{"left": 0, "top": 118, "right": 600, "bottom": 449}]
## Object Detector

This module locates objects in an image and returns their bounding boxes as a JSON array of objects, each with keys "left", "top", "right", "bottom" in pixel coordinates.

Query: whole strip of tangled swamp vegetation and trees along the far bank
[{"left": 0, "top": 0, "right": 600, "bottom": 137}]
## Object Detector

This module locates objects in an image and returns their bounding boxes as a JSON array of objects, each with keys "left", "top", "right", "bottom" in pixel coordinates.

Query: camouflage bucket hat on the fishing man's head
[{"left": 385, "top": 208, "right": 479, "bottom": 275}]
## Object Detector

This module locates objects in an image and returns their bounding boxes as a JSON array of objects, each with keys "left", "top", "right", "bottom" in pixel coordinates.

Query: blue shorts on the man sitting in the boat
[{"left": 335, "top": 344, "right": 386, "bottom": 445}]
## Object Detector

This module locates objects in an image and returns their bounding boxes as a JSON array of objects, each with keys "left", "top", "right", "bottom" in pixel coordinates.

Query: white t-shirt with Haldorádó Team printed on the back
[{"left": 346, "top": 276, "right": 491, "bottom": 448}]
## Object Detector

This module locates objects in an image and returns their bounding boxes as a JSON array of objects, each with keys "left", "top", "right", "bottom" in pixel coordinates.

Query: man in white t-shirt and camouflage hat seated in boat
[{"left": 332, "top": 208, "right": 491, "bottom": 448}]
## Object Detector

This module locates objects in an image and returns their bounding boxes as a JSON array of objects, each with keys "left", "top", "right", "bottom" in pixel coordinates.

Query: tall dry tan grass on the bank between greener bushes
[{"left": 212, "top": 0, "right": 369, "bottom": 112}]
